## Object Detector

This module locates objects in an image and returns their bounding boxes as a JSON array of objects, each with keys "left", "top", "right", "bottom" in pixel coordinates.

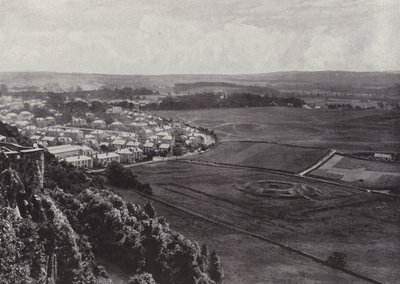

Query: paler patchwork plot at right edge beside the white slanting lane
[{"left": 309, "top": 154, "right": 400, "bottom": 190}]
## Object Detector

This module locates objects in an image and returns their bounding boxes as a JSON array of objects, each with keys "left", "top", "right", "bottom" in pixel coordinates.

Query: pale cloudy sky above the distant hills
[{"left": 0, "top": 0, "right": 400, "bottom": 74}]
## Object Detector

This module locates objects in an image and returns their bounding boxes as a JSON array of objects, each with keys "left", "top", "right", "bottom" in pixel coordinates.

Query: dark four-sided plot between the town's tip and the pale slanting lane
[{"left": 190, "top": 142, "right": 328, "bottom": 173}]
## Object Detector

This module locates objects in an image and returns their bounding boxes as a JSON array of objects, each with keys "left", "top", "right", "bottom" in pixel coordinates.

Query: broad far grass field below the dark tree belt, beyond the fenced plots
[{"left": 152, "top": 107, "right": 400, "bottom": 151}]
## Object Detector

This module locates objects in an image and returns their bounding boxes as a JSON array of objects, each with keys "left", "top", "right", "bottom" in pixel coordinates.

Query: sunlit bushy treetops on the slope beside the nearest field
[{"left": 51, "top": 188, "right": 223, "bottom": 284}]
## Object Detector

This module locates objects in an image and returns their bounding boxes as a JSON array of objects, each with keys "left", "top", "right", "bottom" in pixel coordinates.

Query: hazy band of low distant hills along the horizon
[{"left": 0, "top": 71, "right": 400, "bottom": 93}]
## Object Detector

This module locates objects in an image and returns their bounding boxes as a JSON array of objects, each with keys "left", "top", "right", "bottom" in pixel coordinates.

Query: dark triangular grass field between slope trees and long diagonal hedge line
[{"left": 107, "top": 186, "right": 362, "bottom": 284}]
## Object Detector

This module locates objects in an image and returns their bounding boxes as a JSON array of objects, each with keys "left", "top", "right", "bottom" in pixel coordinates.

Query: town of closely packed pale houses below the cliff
[{"left": 0, "top": 96, "right": 215, "bottom": 169}]
